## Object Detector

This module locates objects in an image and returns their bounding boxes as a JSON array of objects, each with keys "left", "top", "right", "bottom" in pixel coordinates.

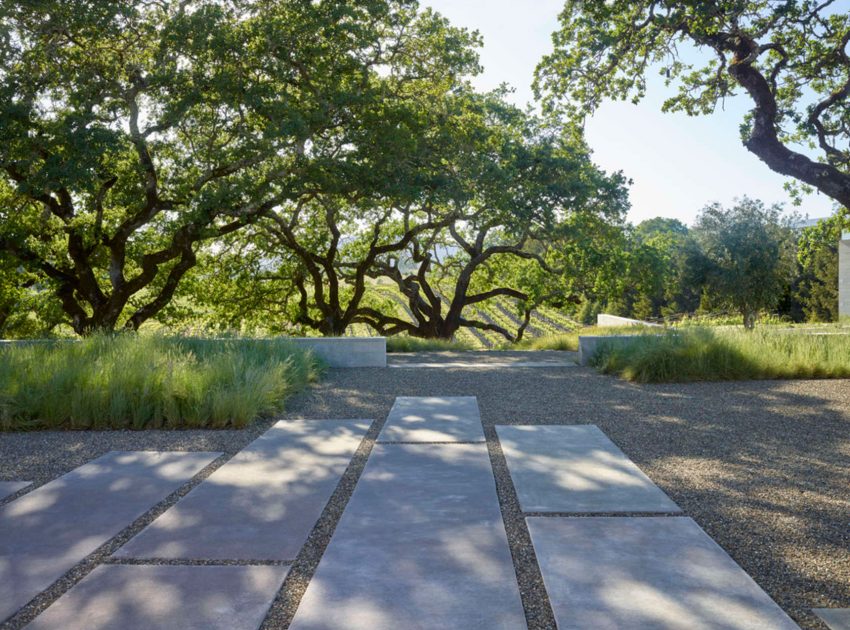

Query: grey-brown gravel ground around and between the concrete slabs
[{"left": 0, "top": 353, "right": 850, "bottom": 629}]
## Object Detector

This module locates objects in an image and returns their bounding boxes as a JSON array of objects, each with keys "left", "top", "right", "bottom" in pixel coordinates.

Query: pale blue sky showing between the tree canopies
[{"left": 421, "top": 0, "right": 833, "bottom": 224}]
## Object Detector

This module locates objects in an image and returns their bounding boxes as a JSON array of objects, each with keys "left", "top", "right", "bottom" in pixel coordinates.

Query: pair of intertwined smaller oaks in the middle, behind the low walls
[{"left": 190, "top": 88, "right": 627, "bottom": 340}]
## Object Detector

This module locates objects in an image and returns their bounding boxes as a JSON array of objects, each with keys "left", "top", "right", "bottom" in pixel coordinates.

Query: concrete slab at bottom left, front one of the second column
[{"left": 27, "top": 564, "right": 289, "bottom": 630}]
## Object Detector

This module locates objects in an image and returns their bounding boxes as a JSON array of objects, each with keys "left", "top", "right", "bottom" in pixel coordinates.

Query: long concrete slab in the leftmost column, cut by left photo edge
[{"left": 0, "top": 451, "right": 220, "bottom": 621}]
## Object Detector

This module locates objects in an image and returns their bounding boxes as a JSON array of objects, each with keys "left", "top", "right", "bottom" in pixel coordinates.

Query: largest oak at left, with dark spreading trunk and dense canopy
[{"left": 0, "top": 0, "right": 477, "bottom": 333}]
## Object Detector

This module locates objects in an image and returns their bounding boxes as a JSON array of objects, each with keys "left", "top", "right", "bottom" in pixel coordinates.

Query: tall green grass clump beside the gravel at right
[{"left": 593, "top": 328, "right": 850, "bottom": 383}]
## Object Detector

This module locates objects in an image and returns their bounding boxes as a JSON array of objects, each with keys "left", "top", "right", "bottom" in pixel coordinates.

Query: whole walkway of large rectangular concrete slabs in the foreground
[{"left": 0, "top": 396, "right": 846, "bottom": 630}]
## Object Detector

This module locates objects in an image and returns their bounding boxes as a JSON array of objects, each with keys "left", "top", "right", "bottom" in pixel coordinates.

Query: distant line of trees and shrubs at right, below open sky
[{"left": 577, "top": 197, "right": 850, "bottom": 327}]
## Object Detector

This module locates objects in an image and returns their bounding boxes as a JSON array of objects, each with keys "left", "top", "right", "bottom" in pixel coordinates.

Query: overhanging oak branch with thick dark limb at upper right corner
[{"left": 536, "top": 0, "right": 850, "bottom": 207}]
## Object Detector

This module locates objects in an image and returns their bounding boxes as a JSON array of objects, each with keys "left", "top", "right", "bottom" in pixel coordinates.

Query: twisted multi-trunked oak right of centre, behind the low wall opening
[{"left": 362, "top": 92, "right": 627, "bottom": 341}]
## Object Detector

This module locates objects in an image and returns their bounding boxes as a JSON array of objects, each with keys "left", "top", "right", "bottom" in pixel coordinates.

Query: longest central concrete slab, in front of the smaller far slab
[{"left": 290, "top": 444, "right": 525, "bottom": 630}]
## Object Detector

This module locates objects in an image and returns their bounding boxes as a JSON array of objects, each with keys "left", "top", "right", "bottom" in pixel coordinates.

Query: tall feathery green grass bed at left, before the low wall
[{"left": 0, "top": 334, "right": 320, "bottom": 431}]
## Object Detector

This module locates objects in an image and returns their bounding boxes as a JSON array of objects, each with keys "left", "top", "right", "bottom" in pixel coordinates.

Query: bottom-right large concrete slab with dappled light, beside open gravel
[{"left": 526, "top": 516, "right": 797, "bottom": 630}]
